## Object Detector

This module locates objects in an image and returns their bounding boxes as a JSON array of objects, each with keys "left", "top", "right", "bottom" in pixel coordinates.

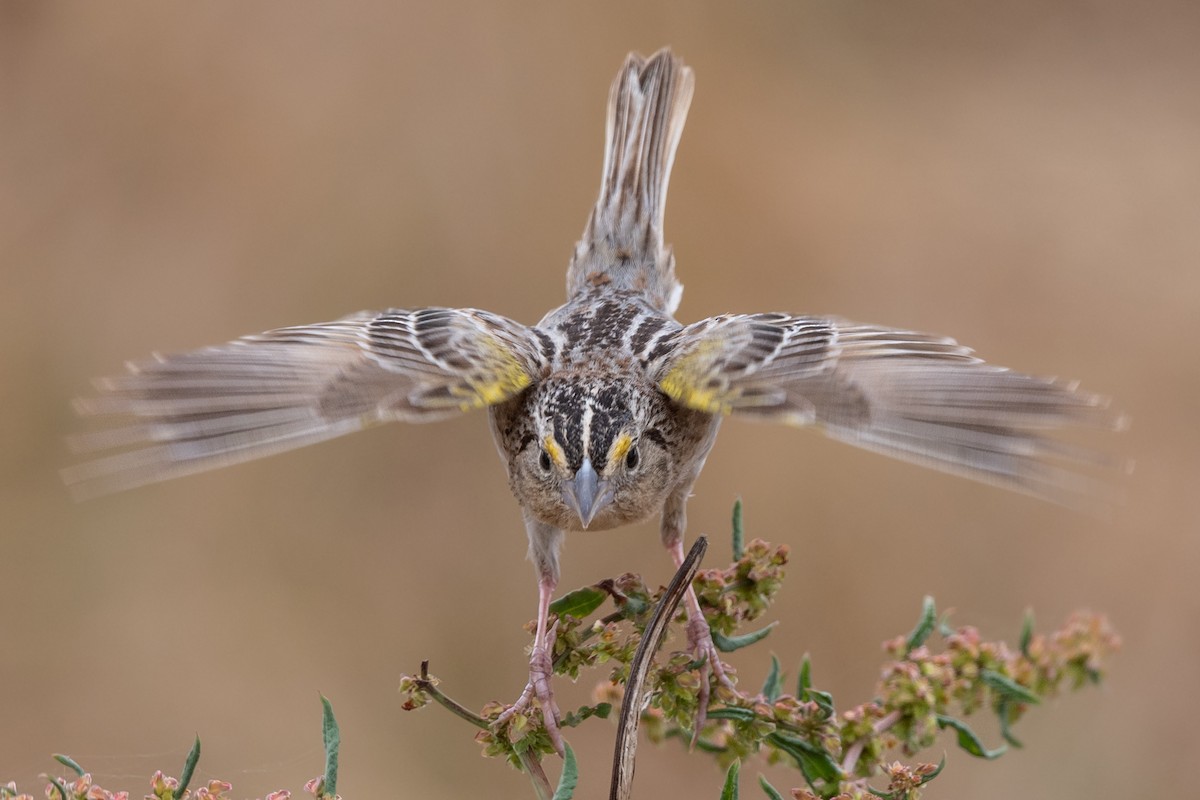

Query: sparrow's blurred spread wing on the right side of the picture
[{"left": 658, "top": 314, "right": 1123, "bottom": 505}]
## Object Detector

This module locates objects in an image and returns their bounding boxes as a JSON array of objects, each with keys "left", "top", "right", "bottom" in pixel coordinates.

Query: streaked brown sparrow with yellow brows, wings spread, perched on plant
[{"left": 64, "top": 48, "right": 1124, "bottom": 752}]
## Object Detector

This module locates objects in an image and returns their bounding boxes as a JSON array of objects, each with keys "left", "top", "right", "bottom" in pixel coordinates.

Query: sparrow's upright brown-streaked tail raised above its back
[{"left": 566, "top": 49, "right": 695, "bottom": 313}]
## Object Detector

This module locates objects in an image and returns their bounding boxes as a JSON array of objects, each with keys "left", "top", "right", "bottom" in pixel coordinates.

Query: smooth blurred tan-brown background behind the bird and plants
[{"left": 0, "top": 0, "right": 1200, "bottom": 800}]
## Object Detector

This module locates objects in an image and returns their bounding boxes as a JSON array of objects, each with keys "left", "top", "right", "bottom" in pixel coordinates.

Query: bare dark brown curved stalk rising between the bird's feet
[{"left": 608, "top": 536, "right": 708, "bottom": 800}]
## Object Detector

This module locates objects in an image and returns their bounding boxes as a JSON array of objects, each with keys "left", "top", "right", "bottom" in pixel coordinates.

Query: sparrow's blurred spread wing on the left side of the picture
[{"left": 64, "top": 308, "right": 542, "bottom": 497}]
